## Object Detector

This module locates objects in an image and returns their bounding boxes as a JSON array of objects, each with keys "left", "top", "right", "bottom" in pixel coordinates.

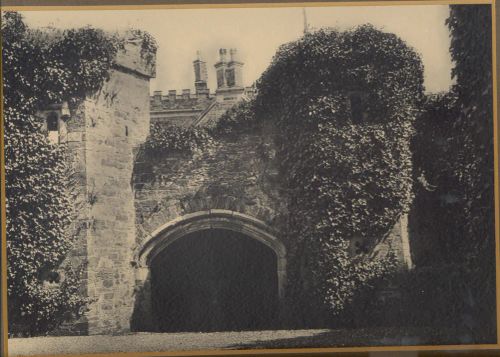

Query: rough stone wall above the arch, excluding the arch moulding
[{"left": 133, "top": 125, "right": 286, "bottom": 250}]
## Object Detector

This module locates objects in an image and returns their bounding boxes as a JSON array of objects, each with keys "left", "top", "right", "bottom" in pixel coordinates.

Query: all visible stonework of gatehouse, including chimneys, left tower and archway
[{"left": 40, "top": 33, "right": 411, "bottom": 334}]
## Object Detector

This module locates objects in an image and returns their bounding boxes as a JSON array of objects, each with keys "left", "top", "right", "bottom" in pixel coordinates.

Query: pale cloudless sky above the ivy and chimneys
[{"left": 22, "top": 5, "right": 452, "bottom": 93}]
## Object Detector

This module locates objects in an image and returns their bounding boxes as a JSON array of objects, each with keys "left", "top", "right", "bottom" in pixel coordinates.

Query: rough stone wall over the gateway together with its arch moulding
[{"left": 133, "top": 125, "right": 286, "bottom": 331}]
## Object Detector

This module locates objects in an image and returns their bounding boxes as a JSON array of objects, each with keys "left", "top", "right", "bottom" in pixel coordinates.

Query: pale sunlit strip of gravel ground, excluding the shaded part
[{"left": 8, "top": 330, "right": 328, "bottom": 357}]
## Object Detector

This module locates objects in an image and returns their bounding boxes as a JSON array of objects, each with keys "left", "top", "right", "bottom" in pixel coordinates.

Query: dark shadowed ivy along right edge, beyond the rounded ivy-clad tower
[{"left": 404, "top": 5, "right": 496, "bottom": 343}]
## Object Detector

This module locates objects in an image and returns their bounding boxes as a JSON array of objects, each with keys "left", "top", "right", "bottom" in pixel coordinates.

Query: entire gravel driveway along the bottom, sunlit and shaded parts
[{"left": 9, "top": 327, "right": 476, "bottom": 356}]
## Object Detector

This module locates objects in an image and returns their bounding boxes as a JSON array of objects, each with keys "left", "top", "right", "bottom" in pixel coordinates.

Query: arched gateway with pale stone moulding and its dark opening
[{"left": 134, "top": 210, "right": 286, "bottom": 332}]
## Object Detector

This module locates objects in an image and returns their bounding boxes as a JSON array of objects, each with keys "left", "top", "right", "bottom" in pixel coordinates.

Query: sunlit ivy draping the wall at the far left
[{"left": 1, "top": 12, "right": 156, "bottom": 336}]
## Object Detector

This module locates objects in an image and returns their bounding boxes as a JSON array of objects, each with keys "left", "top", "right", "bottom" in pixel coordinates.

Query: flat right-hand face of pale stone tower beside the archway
[{"left": 85, "top": 67, "right": 149, "bottom": 333}]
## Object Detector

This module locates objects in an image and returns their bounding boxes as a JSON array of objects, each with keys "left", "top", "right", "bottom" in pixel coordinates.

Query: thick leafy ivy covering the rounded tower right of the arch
[{"left": 256, "top": 25, "right": 423, "bottom": 324}]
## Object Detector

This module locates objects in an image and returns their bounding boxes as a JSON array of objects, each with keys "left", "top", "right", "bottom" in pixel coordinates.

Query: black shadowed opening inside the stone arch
[{"left": 150, "top": 229, "right": 279, "bottom": 332}]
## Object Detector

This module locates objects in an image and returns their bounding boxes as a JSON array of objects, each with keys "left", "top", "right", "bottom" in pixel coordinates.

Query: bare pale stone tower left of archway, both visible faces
[{"left": 61, "top": 41, "right": 154, "bottom": 334}]
